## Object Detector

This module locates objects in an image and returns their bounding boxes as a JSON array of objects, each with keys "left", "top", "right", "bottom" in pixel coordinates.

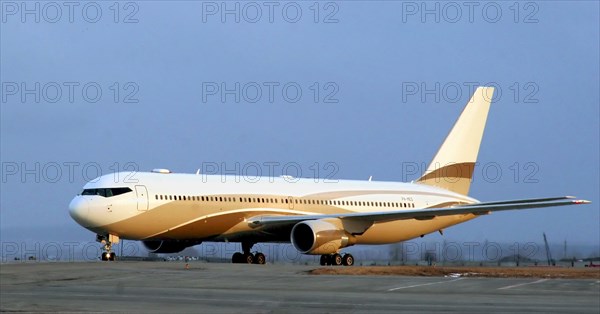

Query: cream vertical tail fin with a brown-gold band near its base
[{"left": 417, "top": 87, "right": 494, "bottom": 195}]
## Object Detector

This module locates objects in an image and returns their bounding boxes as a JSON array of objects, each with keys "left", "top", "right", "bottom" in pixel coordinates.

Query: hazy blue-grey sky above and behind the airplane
[{"left": 0, "top": 1, "right": 600, "bottom": 255}]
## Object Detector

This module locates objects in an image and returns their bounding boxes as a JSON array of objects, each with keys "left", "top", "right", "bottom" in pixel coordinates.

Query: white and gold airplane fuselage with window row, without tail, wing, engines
[{"left": 69, "top": 172, "right": 478, "bottom": 244}]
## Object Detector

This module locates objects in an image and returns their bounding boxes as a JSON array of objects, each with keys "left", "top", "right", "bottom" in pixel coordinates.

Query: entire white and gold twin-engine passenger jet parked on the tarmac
[{"left": 69, "top": 87, "right": 590, "bottom": 266}]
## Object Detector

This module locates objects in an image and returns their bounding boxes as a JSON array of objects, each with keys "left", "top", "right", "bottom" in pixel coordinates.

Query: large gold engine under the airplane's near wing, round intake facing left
[{"left": 291, "top": 220, "right": 356, "bottom": 254}]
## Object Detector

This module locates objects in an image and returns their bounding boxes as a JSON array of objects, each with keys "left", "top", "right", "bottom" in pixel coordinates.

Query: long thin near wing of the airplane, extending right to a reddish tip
[{"left": 248, "top": 196, "right": 591, "bottom": 227}]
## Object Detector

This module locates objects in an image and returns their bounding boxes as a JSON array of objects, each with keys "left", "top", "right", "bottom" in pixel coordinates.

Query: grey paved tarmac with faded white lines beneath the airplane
[{"left": 0, "top": 262, "right": 600, "bottom": 314}]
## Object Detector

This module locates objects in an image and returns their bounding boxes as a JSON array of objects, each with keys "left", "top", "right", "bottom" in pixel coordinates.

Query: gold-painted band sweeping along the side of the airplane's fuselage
[{"left": 99, "top": 190, "right": 474, "bottom": 244}]
